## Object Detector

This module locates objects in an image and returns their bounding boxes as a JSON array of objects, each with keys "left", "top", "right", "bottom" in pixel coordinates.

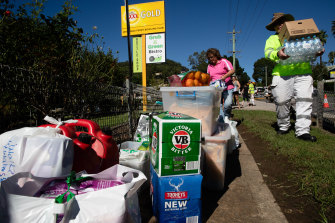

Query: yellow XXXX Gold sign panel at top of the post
[{"left": 121, "top": 1, "right": 165, "bottom": 36}]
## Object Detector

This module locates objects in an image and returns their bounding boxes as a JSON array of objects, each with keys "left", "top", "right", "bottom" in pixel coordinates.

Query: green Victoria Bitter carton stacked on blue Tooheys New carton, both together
[{"left": 150, "top": 112, "right": 202, "bottom": 222}]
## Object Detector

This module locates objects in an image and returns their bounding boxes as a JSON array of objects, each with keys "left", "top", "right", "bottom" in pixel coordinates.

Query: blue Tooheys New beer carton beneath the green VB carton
[{"left": 150, "top": 165, "right": 202, "bottom": 223}]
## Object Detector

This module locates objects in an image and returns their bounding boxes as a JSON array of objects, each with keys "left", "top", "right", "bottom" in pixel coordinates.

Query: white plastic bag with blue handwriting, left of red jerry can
[{"left": 0, "top": 127, "right": 74, "bottom": 182}]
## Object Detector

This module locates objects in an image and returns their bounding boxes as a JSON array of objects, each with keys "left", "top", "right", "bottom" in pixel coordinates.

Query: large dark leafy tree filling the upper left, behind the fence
[{"left": 0, "top": 0, "right": 118, "bottom": 124}]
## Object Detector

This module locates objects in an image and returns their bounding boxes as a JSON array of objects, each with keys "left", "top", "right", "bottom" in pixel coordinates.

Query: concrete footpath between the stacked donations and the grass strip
[{"left": 203, "top": 100, "right": 287, "bottom": 223}]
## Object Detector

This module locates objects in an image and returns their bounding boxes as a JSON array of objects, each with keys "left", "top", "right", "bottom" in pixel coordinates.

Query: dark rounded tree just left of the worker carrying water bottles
[{"left": 252, "top": 57, "right": 276, "bottom": 86}]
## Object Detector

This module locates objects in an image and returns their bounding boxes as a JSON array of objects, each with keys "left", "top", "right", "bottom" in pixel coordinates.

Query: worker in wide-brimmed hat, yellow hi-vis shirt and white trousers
[{"left": 264, "top": 13, "right": 324, "bottom": 142}]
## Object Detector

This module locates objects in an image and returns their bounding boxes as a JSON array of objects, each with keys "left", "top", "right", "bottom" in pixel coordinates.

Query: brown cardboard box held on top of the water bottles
[{"left": 279, "top": 19, "right": 320, "bottom": 44}]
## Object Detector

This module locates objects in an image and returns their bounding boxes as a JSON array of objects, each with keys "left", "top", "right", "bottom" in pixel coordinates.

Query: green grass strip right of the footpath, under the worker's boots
[{"left": 234, "top": 110, "right": 335, "bottom": 220}]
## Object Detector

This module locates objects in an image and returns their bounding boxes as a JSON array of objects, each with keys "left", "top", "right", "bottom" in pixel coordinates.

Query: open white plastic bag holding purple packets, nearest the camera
[{"left": 0, "top": 165, "right": 146, "bottom": 223}]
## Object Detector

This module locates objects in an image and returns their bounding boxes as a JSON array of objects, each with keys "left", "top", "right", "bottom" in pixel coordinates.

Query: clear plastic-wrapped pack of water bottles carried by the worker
[{"left": 280, "top": 36, "right": 323, "bottom": 65}]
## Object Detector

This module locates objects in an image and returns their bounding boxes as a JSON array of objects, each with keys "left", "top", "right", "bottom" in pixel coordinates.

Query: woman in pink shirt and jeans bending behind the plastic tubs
[{"left": 206, "top": 48, "right": 235, "bottom": 119}]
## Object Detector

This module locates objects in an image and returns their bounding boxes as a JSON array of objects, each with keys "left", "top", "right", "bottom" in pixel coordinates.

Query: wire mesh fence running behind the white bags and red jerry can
[{"left": 0, "top": 65, "right": 162, "bottom": 143}]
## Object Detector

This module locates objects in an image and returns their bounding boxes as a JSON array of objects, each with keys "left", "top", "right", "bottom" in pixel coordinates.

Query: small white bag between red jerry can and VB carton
[{"left": 118, "top": 141, "right": 150, "bottom": 179}]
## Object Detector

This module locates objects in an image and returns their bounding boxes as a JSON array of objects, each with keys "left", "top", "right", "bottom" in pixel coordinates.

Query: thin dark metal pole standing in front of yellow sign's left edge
[{"left": 125, "top": 0, "right": 133, "bottom": 138}]
